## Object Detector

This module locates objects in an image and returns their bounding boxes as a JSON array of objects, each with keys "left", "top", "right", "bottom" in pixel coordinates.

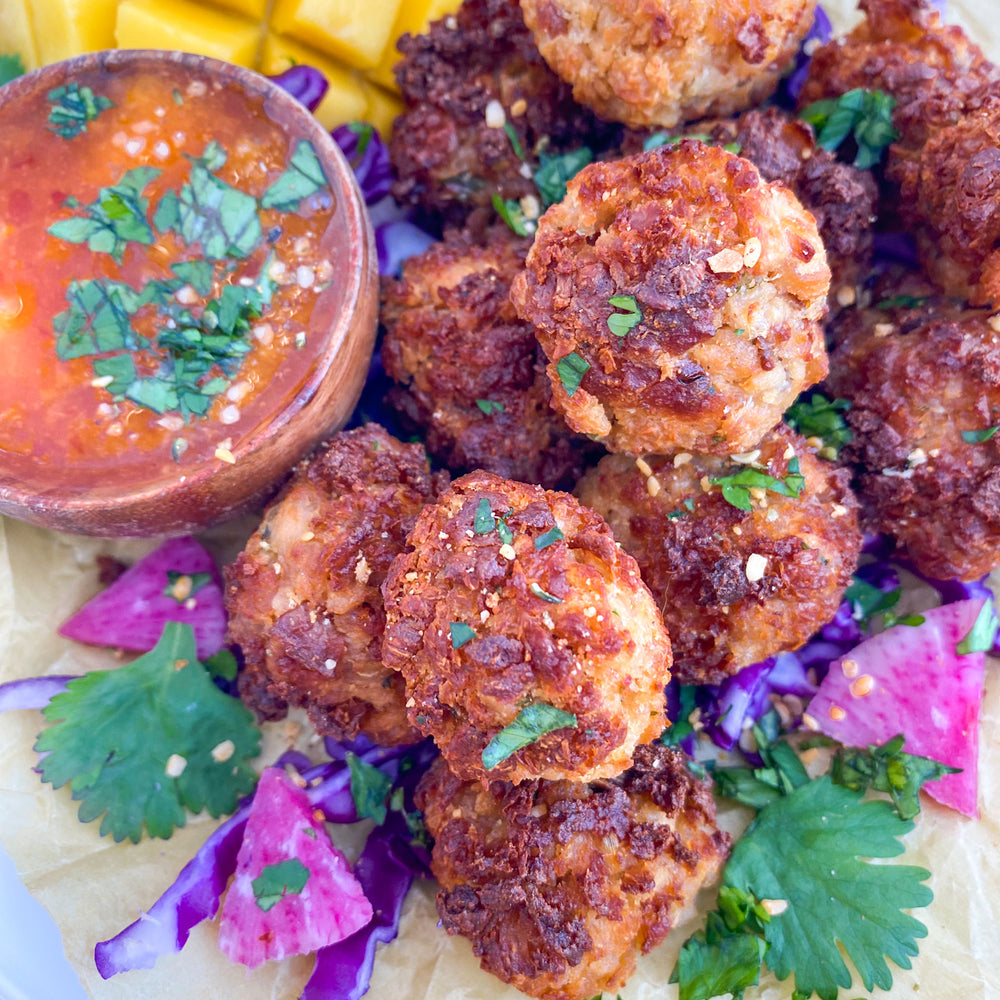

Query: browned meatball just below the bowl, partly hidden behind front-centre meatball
[{"left": 226, "top": 424, "right": 448, "bottom": 746}]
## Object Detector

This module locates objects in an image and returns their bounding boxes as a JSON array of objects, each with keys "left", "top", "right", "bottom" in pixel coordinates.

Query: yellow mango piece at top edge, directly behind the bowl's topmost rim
[{"left": 114, "top": 0, "right": 260, "bottom": 66}]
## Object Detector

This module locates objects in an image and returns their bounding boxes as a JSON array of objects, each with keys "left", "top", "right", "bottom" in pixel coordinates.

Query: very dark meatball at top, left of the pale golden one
[{"left": 389, "top": 0, "right": 616, "bottom": 225}]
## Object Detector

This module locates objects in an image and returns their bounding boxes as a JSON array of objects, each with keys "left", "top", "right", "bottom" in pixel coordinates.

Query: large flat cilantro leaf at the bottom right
[{"left": 724, "top": 776, "right": 932, "bottom": 1000}]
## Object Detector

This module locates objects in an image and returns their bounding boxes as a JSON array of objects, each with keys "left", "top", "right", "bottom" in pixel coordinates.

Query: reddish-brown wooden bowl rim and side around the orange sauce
[{"left": 0, "top": 49, "right": 378, "bottom": 536}]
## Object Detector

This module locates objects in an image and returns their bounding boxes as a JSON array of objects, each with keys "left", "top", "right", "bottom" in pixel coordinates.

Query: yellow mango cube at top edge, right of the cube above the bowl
[{"left": 271, "top": 0, "right": 409, "bottom": 69}]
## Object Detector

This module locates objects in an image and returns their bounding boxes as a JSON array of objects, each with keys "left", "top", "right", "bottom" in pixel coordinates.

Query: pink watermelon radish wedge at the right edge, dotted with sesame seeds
[{"left": 807, "top": 600, "right": 985, "bottom": 817}]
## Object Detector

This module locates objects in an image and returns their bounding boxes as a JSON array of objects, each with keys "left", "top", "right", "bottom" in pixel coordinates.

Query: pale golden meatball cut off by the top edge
[{"left": 521, "top": 0, "right": 816, "bottom": 127}]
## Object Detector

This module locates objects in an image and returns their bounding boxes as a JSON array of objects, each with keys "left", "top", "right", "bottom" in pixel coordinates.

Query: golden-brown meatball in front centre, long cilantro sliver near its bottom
[{"left": 382, "top": 472, "right": 670, "bottom": 783}]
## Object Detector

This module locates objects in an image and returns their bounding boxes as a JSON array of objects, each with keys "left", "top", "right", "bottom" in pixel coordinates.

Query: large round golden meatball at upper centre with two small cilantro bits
[{"left": 511, "top": 139, "right": 830, "bottom": 455}]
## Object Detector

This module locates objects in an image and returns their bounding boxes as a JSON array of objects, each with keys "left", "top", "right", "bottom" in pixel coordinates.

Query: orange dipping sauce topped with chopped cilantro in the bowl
[{"left": 0, "top": 53, "right": 352, "bottom": 493}]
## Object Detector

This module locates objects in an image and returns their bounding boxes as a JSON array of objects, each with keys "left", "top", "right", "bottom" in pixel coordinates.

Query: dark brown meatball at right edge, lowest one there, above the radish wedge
[{"left": 827, "top": 282, "right": 1000, "bottom": 580}]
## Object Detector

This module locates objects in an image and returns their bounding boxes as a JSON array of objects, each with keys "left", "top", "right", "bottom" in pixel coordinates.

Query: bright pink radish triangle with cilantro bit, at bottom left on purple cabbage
[{"left": 219, "top": 767, "right": 372, "bottom": 969}]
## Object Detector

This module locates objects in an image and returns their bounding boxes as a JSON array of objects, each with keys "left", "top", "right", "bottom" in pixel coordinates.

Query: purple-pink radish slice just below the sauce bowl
[{"left": 59, "top": 537, "right": 226, "bottom": 660}]
